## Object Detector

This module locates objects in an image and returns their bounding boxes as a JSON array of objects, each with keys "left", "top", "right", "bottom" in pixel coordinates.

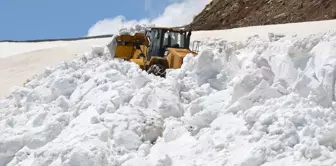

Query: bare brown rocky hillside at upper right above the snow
[{"left": 188, "top": 0, "right": 336, "bottom": 30}]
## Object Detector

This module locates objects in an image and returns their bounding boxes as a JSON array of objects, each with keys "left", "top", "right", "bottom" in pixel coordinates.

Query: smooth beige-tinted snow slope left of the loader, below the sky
[{"left": 0, "top": 38, "right": 111, "bottom": 99}]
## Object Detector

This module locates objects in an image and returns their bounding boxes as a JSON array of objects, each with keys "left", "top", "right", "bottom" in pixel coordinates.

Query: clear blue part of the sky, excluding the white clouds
[{"left": 0, "top": 0, "right": 172, "bottom": 40}]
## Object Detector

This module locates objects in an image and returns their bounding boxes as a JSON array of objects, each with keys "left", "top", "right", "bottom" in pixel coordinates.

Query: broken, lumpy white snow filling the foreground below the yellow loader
[{"left": 0, "top": 22, "right": 336, "bottom": 166}]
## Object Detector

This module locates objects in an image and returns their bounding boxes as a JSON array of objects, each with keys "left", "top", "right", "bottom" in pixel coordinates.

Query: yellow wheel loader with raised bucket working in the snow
[{"left": 109, "top": 27, "right": 197, "bottom": 77}]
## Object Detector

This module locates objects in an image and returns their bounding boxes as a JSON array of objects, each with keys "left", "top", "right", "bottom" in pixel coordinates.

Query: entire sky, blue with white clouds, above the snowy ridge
[{"left": 0, "top": 0, "right": 209, "bottom": 40}]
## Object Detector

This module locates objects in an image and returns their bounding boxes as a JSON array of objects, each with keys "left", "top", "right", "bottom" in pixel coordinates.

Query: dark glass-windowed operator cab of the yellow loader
[{"left": 146, "top": 27, "right": 191, "bottom": 61}]
